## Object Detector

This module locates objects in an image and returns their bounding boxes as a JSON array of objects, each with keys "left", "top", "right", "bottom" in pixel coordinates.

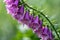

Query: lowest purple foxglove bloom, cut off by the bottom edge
[{"left": 34, "top": 27, "right": 53, "bottom": 40}]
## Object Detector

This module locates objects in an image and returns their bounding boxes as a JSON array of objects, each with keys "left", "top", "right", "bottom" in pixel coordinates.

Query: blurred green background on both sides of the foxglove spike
[{"left": 0, "top": 0, "right": 60, "bottom": 40}]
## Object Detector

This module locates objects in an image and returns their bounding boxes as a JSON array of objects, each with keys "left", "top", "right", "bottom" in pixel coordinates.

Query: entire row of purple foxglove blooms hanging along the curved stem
[{"left": 4, "top": 0, "right": 53, "bottom": 40}]
